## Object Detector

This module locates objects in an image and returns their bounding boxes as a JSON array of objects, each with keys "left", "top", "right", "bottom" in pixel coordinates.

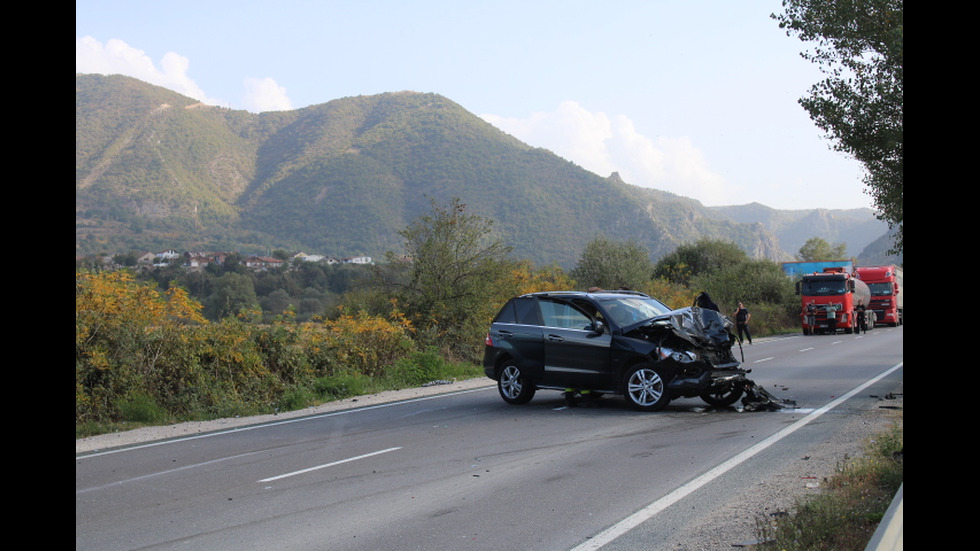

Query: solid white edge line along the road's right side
[{"left": 570, "top": 362, "right": 904, "bottom": 551}]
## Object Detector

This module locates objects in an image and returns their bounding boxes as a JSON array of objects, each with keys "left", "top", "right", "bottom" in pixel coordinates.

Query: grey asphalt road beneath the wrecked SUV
[{"left": 75, "top": 327, "right": 903, "bottom": 551}]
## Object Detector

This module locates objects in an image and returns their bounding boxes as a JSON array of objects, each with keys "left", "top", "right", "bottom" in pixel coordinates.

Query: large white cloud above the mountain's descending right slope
[{"left": 483, "top": 101, "right": 732, "bottom": 205}]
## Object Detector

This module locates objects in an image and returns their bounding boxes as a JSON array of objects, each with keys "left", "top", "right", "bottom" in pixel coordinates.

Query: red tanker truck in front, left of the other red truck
[{"left": 796, "top": 266, "right": 874, "bottom": 335}]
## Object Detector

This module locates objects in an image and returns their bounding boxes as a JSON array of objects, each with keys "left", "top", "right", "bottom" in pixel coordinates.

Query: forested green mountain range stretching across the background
[{"left": 75, "top": 75, "right": 887, "bottom": 267}]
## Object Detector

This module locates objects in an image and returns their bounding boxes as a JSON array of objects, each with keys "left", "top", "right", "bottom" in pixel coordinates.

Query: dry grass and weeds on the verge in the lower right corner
[{"left": 756, "top": 419, "right": 905, "bottom": 551}]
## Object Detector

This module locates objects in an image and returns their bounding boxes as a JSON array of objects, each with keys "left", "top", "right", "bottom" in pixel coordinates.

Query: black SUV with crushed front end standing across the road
[{"left": 483, "top": 291, "right": 748, "bottom": 411}]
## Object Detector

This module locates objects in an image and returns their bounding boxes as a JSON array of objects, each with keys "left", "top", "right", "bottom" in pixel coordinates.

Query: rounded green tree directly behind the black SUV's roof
[{"left": 570, "top": 236, "right": 653, "bottom": 289}]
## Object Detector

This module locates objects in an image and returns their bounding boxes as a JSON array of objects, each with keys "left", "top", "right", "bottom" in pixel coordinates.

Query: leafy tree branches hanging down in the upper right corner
[{"left": 772, "top": 0, "right": 904, "bottom": 253}]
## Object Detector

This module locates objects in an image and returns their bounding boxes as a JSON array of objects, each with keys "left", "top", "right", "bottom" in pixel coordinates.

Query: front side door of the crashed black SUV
[{"left": 538, "top": 298, "right": 612, "bottom": 390}]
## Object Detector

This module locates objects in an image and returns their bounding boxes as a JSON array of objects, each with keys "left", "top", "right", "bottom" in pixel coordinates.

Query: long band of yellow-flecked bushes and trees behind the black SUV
[{"left": 75, "top": 200, "right": 852, "bottom": 437}]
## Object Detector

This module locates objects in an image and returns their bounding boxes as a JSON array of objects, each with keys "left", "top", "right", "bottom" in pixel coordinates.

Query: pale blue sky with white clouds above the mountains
[{"left": 75, "top": 0, "right": 873, "bottom": 209}]
